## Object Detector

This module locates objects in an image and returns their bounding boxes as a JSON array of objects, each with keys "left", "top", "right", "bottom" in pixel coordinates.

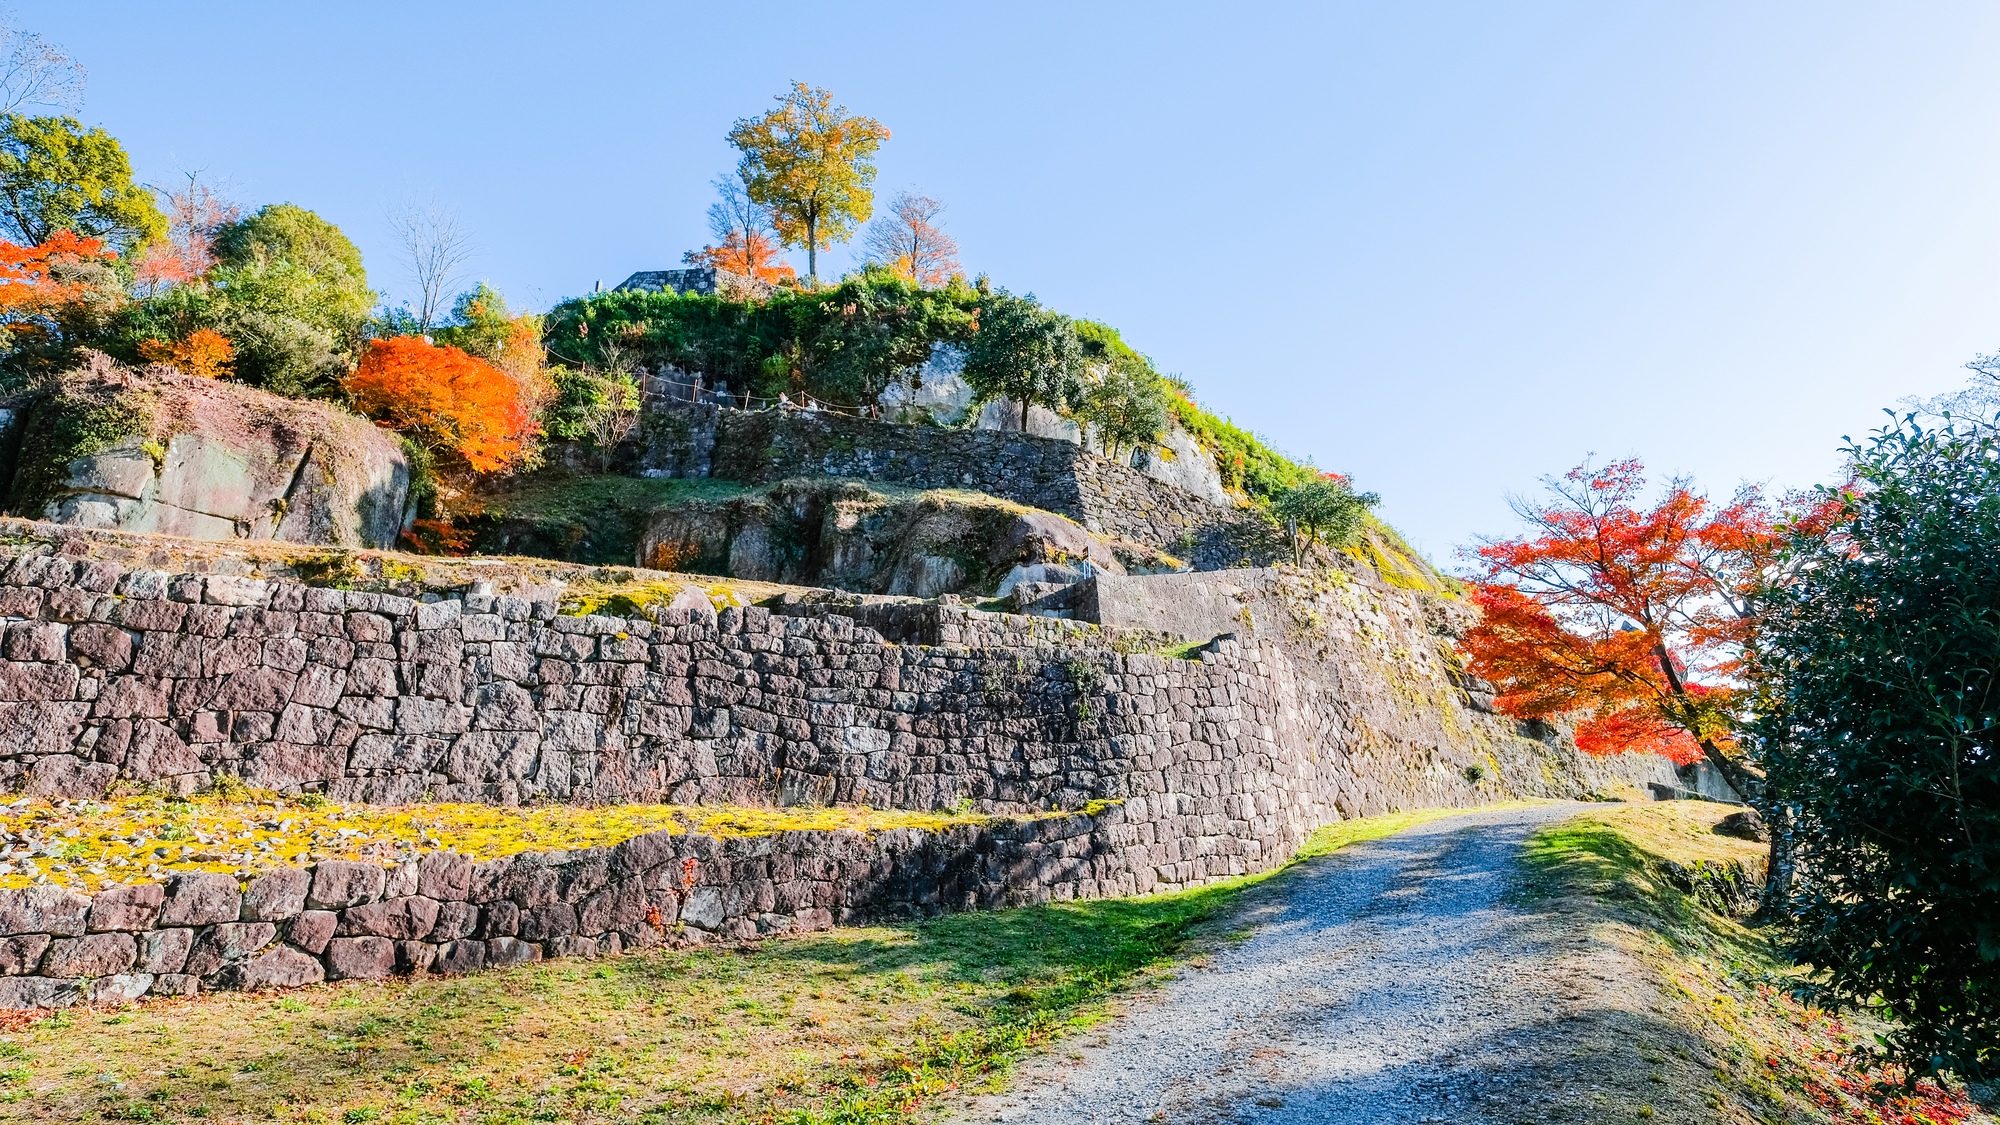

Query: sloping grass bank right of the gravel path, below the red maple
[{"left": 1530, "top": 801, "right": 1992, "bottom": 1125}]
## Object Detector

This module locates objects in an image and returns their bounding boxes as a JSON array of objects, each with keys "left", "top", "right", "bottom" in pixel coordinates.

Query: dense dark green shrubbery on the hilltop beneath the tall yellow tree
[{"left": 546, "top": 268, "right": 978, "bottom": 406}]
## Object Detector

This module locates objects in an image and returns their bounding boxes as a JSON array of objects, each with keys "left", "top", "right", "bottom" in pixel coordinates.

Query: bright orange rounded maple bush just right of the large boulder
[{"left": 346, "top": 336, "right": 538, "bottom": 472}]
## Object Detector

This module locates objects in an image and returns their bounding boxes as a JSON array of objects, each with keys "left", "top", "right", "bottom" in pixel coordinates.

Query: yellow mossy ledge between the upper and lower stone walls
[{"left": 0, "top": 793, "right": 990, "bottom": 893}]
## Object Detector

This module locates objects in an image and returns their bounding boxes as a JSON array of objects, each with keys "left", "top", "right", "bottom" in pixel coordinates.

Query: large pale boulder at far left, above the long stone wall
[{"left": 0, "top": 352, "right": 410, "bottom": 546}]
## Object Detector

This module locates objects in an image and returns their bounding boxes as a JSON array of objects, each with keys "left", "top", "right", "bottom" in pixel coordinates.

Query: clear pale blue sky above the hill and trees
[{"left": 18, "top": 0, "right": 2000, "bottom": 563}]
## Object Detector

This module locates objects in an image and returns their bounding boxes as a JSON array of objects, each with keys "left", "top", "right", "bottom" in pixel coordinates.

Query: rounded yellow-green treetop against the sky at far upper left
[{"left": 0, "top": 114, "right": 166, "bottom": 254}]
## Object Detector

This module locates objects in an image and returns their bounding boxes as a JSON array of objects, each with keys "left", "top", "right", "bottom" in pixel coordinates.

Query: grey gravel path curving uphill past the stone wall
[{"left": 966, "top": 805, "right": 1648, "bottom": 1125}]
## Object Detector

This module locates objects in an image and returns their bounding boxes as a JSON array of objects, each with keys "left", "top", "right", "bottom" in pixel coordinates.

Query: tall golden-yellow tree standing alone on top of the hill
[{"left": 730, "top": 82, "right": 888, "bottom": 286}]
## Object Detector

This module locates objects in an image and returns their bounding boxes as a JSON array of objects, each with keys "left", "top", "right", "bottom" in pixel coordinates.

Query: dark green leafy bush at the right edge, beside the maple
[{"left": 1756, "top": 418, "right": 2000, "bottom": 1079}]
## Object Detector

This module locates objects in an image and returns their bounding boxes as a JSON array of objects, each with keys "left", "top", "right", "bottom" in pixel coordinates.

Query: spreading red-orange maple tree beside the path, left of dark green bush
[{"left": 1462, "top": 458, "right": 1810, "bottom": 797}]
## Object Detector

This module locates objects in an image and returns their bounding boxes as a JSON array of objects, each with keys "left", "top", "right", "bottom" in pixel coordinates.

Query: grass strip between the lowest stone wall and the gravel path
[{"left": 0, "top": 809, "right": 1480, "bottom": 1125}]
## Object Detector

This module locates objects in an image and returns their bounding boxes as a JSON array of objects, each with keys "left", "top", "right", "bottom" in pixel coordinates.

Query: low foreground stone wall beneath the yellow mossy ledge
[{"left": 0, "top": 805, "right": 1128, "bottom": 1009}]
